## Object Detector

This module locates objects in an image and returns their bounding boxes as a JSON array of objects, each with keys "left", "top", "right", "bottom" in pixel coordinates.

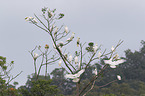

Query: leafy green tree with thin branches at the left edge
[{"left": 0, "top": 56, "right": 21, "bottom": 96}]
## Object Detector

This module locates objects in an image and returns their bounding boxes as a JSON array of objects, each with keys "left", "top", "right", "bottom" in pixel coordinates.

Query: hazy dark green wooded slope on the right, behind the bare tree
[{"left": 50, "top": 41, "right": 145, "bottom": 96}]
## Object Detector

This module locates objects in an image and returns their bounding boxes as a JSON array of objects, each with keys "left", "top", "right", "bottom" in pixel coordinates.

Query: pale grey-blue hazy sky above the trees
[{"left": 0, "top": 0, "right": 145, "bottom": 84}]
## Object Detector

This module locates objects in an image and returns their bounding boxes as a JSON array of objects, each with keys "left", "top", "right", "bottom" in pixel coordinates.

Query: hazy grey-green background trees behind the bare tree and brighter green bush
[{"left": 17, "top": 41, "right": 145, "bottom": 96}]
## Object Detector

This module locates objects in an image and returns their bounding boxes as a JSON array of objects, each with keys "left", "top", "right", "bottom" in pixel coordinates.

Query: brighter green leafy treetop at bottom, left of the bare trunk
[{"left": 19, "top": 75, "right": 61, "bottom": 96}]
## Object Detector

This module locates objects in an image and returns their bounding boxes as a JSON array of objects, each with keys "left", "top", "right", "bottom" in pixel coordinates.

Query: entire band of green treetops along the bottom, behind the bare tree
[{"left": 0, "top": 41, "right": 145, "bottom": 96}]
